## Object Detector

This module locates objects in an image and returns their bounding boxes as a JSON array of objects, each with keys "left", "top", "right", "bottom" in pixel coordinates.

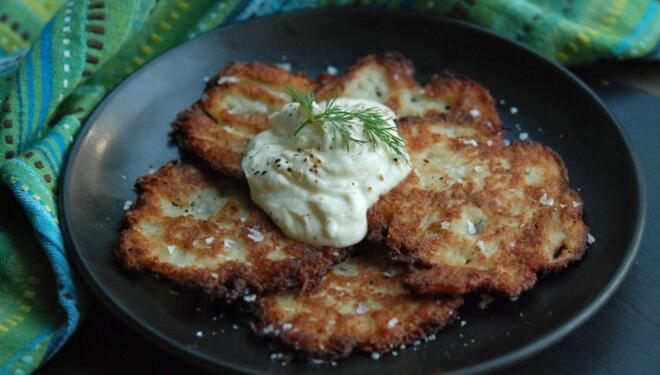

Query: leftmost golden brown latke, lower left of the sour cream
[{"left": 117, "top": 163, "right": 348, "bottom": 299}]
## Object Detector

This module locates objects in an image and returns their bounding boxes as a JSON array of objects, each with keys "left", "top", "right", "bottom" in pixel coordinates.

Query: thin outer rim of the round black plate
[{"left": 57, "top": 6, "right": 647, "bottom": 374}]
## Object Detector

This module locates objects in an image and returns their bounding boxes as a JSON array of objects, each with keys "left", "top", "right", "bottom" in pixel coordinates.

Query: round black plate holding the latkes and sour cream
[{"left": 61, "top": 8, "right": 645, "bottom": 374}]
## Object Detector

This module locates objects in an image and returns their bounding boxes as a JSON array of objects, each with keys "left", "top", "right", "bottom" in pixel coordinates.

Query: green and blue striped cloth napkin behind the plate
[{"left": 0, "top": 0, "right": 660, "bottom": 375}]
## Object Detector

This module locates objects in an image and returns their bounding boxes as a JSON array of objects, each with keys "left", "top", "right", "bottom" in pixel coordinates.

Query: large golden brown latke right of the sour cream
[{"left": 368, "top": 115, "right": 588, "bottom": 296}]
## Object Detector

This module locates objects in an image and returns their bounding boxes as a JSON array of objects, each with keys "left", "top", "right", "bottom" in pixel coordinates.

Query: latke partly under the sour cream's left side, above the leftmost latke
[{"left": 172, "top": 62, "right": 315, "bottom": 178}]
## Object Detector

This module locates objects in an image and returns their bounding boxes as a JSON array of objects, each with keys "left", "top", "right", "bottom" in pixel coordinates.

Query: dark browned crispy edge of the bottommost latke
[{"left": 238, "top": 253, "right": 464, "bottom": 361}]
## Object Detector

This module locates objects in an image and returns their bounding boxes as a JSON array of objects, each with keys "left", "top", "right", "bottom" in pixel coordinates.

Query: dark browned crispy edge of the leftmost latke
[{"left": 115, "top": 161, "right": 350, "bottom": 300}]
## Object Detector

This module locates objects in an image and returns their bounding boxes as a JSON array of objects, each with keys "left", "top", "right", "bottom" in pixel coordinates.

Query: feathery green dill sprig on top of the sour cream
[{"left": 286, "top": 86, "right": 410, "bottom": 165}]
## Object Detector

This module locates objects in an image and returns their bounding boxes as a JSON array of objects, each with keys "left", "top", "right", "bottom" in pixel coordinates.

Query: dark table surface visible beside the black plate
[{"left": 38, "top": 62, "right": 660, "bottom": 375}]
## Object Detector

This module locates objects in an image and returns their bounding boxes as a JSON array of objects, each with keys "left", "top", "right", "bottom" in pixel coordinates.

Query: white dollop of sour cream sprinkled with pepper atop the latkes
[{"left": 241, "top": 98, "right": 411, "bottom": 247}]
